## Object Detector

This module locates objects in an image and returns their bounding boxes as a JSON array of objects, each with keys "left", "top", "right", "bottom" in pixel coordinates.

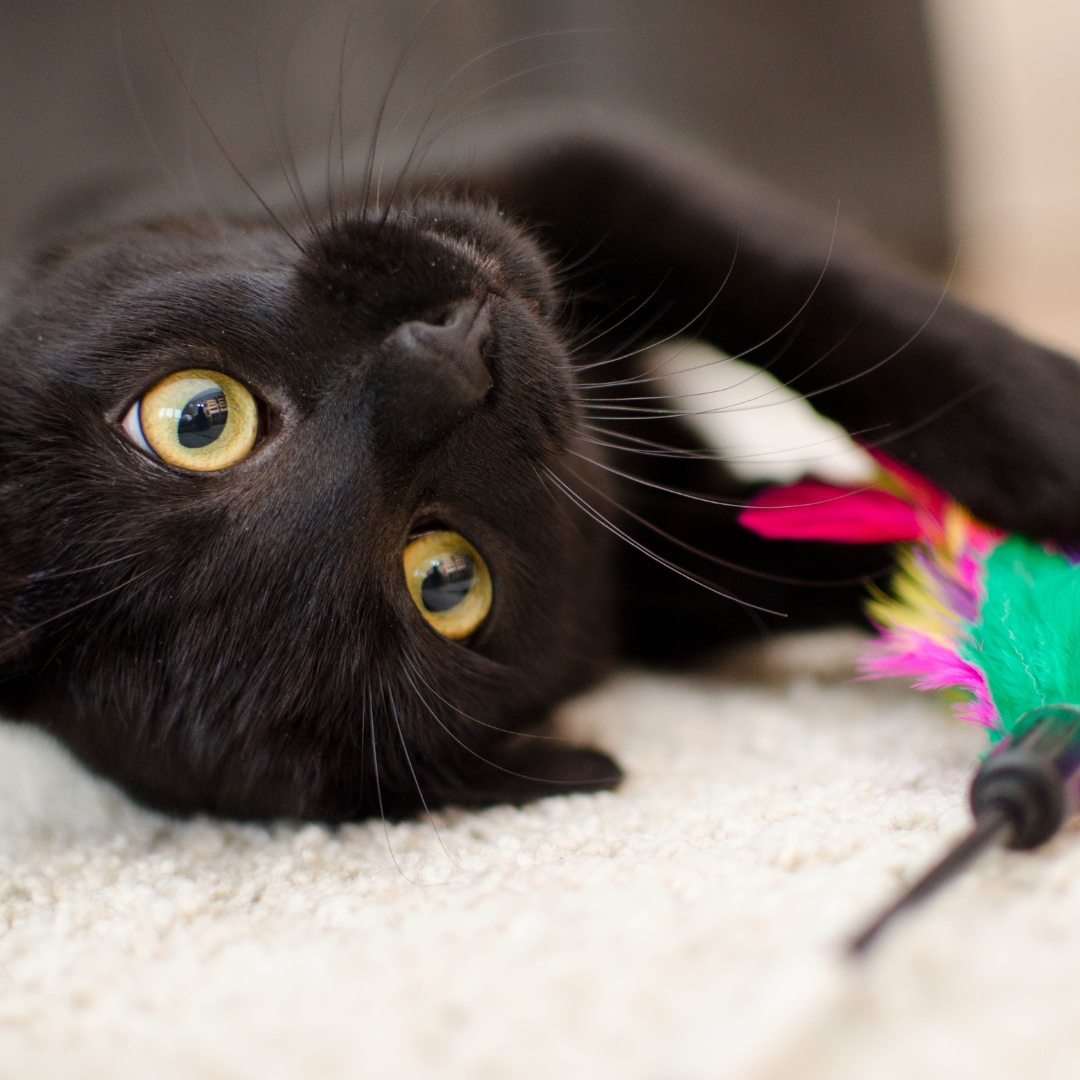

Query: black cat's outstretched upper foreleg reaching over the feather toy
[{"left": 471, "top": 120, "right": 1080, "bottom": 541}]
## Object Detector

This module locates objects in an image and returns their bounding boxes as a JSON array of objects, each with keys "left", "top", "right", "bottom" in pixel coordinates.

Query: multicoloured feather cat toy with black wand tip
[{"left": 740, "top": 451, "right": 1080, "bottom": 956}]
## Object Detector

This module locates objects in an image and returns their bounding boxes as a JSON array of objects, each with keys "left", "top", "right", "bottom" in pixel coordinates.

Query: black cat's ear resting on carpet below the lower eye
[{"left": 453, "top": 735, "right": 622, "bottom": 806}]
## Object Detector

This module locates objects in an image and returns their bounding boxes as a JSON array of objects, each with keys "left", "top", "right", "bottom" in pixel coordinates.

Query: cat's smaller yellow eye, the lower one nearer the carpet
[{"left": 405, "top": 532, "right": 491, "bottom": 642}]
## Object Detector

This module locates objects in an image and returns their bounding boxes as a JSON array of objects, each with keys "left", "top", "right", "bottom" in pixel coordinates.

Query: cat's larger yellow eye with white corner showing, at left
[{"left": 122, "top": 368, "right": 259, "bottom": 472}]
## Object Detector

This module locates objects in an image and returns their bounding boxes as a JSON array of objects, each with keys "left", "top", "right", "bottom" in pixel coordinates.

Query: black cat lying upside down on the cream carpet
[{"left": 0, "top": 111, "right": 1080, "bottom": 820}]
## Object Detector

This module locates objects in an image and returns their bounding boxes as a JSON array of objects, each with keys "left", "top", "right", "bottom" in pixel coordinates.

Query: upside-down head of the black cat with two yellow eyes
[{"left": 0, "top": 196, "right": 617, "bottom": 820}]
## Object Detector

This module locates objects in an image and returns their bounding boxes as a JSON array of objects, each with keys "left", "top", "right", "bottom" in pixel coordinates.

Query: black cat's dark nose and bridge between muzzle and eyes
[{"left": 373, "top": 297, "right": 492, "bottom": 451}]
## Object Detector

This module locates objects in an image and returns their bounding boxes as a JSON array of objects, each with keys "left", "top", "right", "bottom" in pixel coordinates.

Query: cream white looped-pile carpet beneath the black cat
[{"left": 0, "top": 634, "right": 1080, "bottom": 1080}]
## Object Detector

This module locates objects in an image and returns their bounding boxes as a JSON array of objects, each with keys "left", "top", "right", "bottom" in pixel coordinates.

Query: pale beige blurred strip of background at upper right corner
[{"left": 928, "top": 0, "right": 1080, "bottom": 355}]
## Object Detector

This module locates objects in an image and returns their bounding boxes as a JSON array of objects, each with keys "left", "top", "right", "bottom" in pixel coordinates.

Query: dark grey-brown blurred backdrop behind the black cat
[{"left": 0, "top": 0, "right": 946, "bottom": 266}]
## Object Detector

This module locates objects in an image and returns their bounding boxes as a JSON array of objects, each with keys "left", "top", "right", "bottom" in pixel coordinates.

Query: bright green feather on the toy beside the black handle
[{"left": 962, "top": 537, "right": 1080, "bottom": 742}]
